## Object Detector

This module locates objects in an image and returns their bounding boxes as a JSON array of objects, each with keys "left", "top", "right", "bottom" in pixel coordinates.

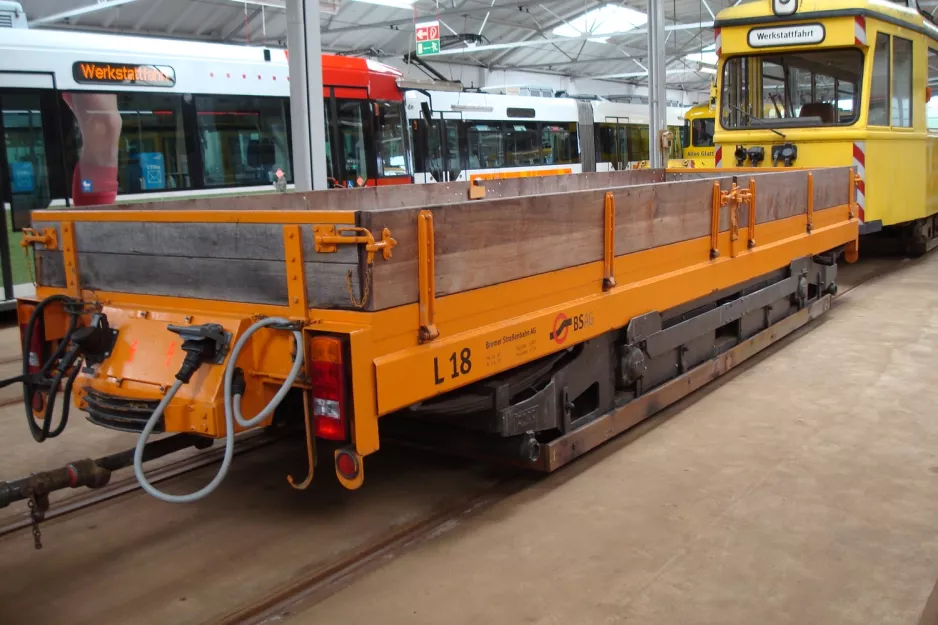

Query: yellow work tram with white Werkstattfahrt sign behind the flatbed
[{"left": 714, "top": 0, "right": 938, "bottom": 254}]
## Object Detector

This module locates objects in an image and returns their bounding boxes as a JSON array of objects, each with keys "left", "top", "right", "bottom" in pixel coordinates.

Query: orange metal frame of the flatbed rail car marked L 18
[{"left": 20, "top": 169, "right": 858, "bottom": 488}]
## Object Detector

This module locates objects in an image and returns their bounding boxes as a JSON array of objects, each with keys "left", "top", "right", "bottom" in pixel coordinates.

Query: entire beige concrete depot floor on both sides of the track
[{"left": 0, "top": 253, "right": 938, "bottom": 625}]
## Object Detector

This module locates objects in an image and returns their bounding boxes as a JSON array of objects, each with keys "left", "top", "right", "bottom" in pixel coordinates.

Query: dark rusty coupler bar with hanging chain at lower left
[{"left": 0, "top": 434, "right": 207, "bottom": 549}]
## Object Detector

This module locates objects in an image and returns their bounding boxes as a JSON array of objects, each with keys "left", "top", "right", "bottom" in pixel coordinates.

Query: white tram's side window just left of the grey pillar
[{"left": 195, "top": 95, "right": 293, "bottom": 187}]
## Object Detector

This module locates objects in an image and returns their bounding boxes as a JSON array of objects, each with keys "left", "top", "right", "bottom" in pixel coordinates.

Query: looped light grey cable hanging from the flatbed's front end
[{"left": 134, "top": 317, "right": 303, "bottom": 503}]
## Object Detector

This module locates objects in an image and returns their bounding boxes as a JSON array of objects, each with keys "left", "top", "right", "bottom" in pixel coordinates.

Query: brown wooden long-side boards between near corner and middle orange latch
[{"left": 361, "top": 177, "right": 745, "bottom": 310}]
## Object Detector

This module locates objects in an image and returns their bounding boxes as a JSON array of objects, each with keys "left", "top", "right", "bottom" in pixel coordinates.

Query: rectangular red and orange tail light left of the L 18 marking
[{"left": 309, "top": 337, "right": 348, "bottom": 441}]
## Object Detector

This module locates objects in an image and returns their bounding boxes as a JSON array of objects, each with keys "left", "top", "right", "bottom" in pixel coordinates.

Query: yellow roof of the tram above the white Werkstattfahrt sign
[{"left": 715, "top": 0, "right": 938, "bottom": 35}]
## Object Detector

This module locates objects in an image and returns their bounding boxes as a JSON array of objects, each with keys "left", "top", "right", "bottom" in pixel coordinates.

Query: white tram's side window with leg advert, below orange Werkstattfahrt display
[{"left": 65, "top": 91, "right": 192, "bottom": 194}]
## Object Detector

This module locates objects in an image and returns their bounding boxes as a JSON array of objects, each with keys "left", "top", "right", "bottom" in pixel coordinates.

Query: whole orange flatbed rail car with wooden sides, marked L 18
[{"left": 12, "top": 168, "right": 858, "bottom": 498}]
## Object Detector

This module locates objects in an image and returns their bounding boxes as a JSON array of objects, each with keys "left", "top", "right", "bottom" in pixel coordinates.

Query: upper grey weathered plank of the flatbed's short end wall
[{"left": 68, "top": 222, "right": 358, "bottom": 263}]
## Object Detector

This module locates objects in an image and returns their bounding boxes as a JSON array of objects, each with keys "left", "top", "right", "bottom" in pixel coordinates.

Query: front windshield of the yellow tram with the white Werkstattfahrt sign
[{"left": 720, "top": 48, "right": 863, "bottom": 129}]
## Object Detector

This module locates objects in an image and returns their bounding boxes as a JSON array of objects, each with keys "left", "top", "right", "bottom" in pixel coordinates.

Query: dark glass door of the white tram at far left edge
[{"left": 0, "top": 72, "right": 57, "bottom": 300}]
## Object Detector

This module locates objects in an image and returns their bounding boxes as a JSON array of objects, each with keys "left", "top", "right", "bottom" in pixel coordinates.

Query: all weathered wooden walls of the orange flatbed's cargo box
[{"left": 27, "top": 168, "right": 851, "bottom": 311}]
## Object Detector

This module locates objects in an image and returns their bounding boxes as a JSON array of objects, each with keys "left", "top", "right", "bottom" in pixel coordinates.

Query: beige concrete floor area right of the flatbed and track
[{"left": 290, "top": 253, "right": 938, "bottom": 625}]
